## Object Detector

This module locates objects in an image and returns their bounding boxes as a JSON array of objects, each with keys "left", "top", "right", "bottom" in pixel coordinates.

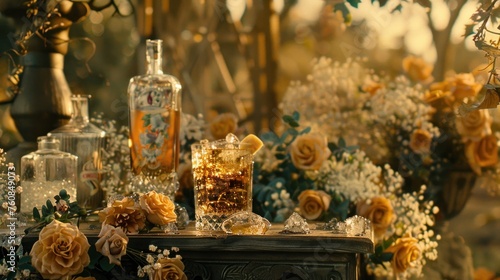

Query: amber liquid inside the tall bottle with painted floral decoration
[{"left": 130, "top": 109, "right": 180, "bottom": 177}]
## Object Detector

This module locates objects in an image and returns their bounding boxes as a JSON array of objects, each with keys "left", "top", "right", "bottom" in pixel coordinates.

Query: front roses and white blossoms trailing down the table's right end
[{"left": 253, "top": 113, "right": 439, "bottom": 278}]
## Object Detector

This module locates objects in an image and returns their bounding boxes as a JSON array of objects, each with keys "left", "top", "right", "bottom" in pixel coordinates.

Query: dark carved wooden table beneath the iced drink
[{"left": 23, "top": 224, "right": 374, "bottom": 280}]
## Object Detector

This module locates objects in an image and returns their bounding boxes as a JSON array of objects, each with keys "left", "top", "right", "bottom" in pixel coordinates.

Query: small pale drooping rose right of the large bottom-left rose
[{"left": 95, "top": 224, "right": 128, "bottom": 265}]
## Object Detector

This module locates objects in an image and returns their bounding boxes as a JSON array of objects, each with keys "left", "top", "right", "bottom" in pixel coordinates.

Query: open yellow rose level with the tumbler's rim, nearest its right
[{"left": 290, "top": 134, "right": 331, "bottom": 170}]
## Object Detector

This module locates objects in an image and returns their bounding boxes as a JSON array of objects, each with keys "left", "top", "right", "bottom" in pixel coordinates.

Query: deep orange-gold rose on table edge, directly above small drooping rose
[{"left": 99, "top": 197, "right": 146, "bottom": 233}]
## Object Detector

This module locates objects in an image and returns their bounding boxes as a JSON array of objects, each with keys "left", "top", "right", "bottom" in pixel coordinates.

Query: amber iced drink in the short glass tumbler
[{"left": 193, "top": 145, "right": 253, "bottom": 230}]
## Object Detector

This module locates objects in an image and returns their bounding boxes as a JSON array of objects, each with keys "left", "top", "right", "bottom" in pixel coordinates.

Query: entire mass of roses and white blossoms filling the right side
[{"left": 270, "top": 57, "right": 500, "bottom": 277}]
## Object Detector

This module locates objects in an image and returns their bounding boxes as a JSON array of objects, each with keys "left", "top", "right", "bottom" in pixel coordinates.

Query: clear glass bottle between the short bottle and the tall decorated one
[{"left": 49, "top": 95, "right": 106, "bottom": 209}]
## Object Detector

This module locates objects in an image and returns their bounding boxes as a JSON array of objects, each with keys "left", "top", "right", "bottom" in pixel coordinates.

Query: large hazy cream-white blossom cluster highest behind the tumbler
[{"left": 280, "top": 57, "right": 378, "bottom": 158}]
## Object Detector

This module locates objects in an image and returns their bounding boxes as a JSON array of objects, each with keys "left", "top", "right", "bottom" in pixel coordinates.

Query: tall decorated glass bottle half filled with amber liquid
[{"left": 128, "top": 40, "right": 182, "bottom": 195}]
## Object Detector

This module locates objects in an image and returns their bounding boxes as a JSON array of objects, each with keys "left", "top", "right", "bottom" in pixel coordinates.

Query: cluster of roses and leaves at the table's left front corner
[{"left": 0, "top": 186, "right": 187, "bottom": 279}]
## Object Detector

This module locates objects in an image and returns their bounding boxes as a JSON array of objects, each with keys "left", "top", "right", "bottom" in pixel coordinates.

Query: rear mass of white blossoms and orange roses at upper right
[{"left": 281, "top": 57, "right": 499, "bottom": 215}]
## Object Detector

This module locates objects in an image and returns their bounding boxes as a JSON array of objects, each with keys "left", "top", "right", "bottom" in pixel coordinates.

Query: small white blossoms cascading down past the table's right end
[{"left": 319, "top": 151, "right": 440, "bottom": 279}]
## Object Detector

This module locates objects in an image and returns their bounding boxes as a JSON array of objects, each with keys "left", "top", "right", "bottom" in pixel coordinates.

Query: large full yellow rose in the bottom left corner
[{"left": 30, "top": 220, "right": 90, "bottom": 279}]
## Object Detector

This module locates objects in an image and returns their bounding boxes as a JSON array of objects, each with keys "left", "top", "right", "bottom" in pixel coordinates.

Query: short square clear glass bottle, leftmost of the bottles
[{"left": 21, "top": 136, "right": 77, "bottom": 217}]
